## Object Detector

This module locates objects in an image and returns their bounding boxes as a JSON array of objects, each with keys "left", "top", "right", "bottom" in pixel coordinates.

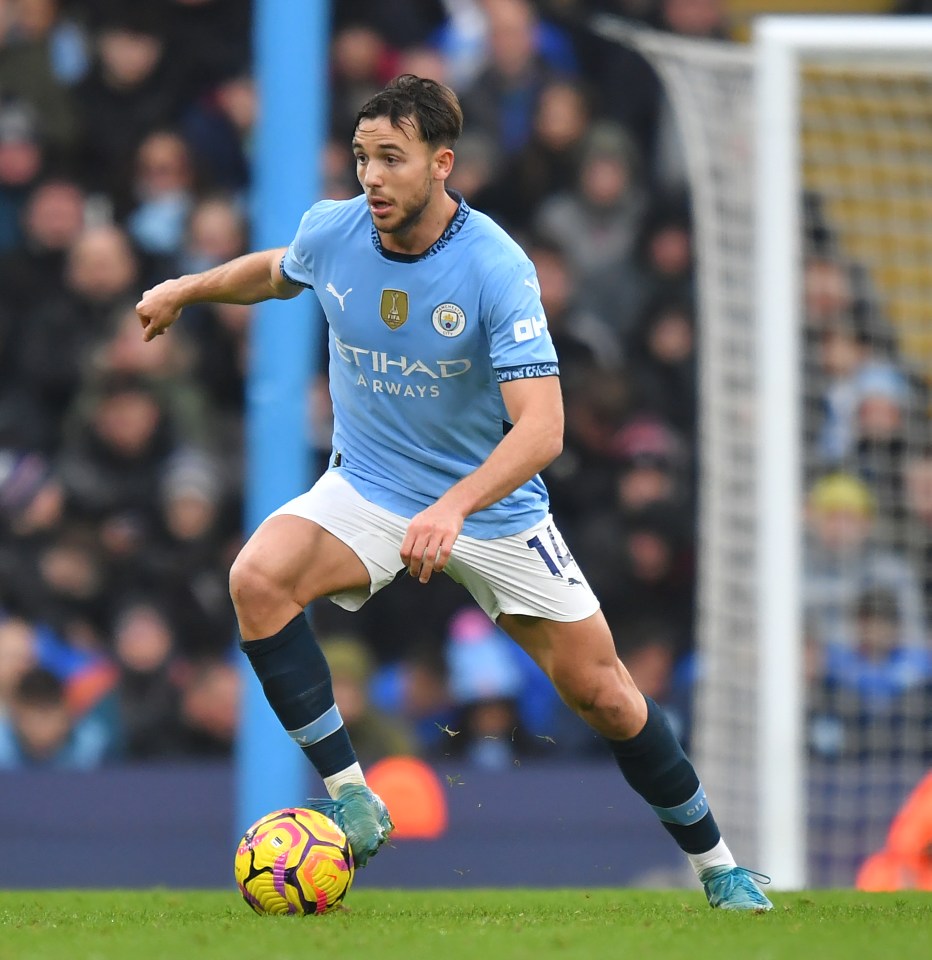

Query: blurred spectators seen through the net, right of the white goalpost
[{"left": 803, "top": 196, "right": 932, "bottom": 764}]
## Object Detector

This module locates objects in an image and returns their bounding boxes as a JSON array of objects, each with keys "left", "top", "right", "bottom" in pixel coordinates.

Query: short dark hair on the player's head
[{"left": 354, "top": 73, "right": 463, "bottom": 147}]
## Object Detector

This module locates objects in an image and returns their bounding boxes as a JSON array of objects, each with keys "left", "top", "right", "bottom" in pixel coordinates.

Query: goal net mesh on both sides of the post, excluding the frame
[{"left": 602, "top": 16, "right": 932, "bottom": 886}]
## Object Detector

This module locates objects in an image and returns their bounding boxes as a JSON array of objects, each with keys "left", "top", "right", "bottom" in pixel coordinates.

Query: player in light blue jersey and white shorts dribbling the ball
[{"left": 136, "top": 75, "right": 771, "bottom": 911}]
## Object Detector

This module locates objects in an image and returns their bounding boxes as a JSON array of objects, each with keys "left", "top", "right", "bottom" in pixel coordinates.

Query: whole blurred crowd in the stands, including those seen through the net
[{"left": 0, "top": 0, "right": 932, "bottom": 768}]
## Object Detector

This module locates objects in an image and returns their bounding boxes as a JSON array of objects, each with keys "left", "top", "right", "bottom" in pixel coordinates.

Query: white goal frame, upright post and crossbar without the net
[{"left": 753, "top": 16, "right": 932, "bottom": 890}]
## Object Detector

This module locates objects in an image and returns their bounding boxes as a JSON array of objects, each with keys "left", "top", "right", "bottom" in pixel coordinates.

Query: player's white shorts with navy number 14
[{"left": 270, "top": 470, "right": 599, "bottom": 622}]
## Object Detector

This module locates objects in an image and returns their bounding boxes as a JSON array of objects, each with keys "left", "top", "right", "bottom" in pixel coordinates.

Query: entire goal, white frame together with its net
[{"left": 595, "top": 17, "right": 932, "bottom": 888}]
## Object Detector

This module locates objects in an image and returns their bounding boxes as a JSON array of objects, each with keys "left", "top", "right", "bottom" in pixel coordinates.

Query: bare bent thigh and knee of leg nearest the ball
[{"left": 231, "top": 514, "right": 370, "bottom": 606}]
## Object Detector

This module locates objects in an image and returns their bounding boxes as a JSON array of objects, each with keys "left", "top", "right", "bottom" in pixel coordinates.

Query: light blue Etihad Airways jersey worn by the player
[{"left": 281, "top": 196, "right": 559, "bottom": 540}]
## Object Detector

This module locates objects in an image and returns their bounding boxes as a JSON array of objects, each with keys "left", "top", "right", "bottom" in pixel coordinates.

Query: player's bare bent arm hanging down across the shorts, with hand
[{"left": 401, "top": 376, "right": 563, "bottom": 583}]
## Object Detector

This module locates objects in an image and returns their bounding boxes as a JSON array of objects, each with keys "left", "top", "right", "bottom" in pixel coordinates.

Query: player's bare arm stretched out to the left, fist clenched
[{"left": 136, "top": 247, "right": 304, "bottom": 341}]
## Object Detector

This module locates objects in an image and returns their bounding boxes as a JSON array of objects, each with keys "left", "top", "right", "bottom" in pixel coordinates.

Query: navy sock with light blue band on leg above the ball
[{"left": 240, "top": 612, "right": 356, "bottom": 777}]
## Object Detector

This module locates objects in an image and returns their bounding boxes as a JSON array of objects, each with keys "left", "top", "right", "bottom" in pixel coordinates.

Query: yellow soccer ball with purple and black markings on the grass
[{"left": 234, "top": 807, "right": 355, "bottom": 916}]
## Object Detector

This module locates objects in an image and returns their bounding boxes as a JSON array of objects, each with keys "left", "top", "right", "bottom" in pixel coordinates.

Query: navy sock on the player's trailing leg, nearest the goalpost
[{"left": 608, "top": 697, "right": 722, "bottom": 853}]
